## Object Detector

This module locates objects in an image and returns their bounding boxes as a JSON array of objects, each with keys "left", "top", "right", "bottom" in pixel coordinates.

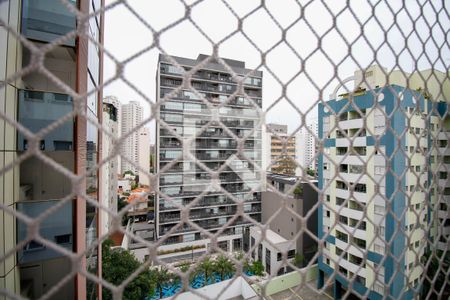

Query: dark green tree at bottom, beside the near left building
[{"left": 102, "top": 240, "right": 155, "bottom": 300}]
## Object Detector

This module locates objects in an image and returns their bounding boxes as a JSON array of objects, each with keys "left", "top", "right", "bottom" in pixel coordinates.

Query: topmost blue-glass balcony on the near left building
[{"left": 22, "top": 0, "right": 76, "bottom": 47}]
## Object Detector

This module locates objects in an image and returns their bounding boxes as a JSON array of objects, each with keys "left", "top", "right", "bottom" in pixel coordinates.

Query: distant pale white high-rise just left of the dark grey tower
[{"left": 120, "top": 101, "right": 144, "bottom": 174}]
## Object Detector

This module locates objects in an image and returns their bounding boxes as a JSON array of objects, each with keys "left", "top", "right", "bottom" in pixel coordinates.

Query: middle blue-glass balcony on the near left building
[{"left": 17, "top": 90, "right": 74, "bottom": 151}]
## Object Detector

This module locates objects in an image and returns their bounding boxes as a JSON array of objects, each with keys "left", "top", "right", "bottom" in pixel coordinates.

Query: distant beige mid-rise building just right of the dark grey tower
[{"left": 263, "top": 123, "right": 297, "bottom": 175}]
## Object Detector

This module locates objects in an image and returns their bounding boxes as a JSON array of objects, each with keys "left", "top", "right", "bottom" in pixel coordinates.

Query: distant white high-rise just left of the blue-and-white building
[{"left": 295, "top": 120, "right": 317, "bottom": 175}]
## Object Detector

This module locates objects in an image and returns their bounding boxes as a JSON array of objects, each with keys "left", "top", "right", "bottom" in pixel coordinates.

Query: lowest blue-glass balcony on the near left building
[{"left": 16, "top": 200, "right": 73, "bottom": 264}]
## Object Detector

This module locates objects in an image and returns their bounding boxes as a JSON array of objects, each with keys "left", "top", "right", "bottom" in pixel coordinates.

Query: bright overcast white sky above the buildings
[{"left": 104, "top": 0, "right": 450, "bottom": 143}]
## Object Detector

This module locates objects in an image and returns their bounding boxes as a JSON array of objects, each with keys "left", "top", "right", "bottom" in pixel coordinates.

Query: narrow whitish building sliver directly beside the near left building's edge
[{"left": 100, "top": 96, "right": 120, "bottom": 233}]
